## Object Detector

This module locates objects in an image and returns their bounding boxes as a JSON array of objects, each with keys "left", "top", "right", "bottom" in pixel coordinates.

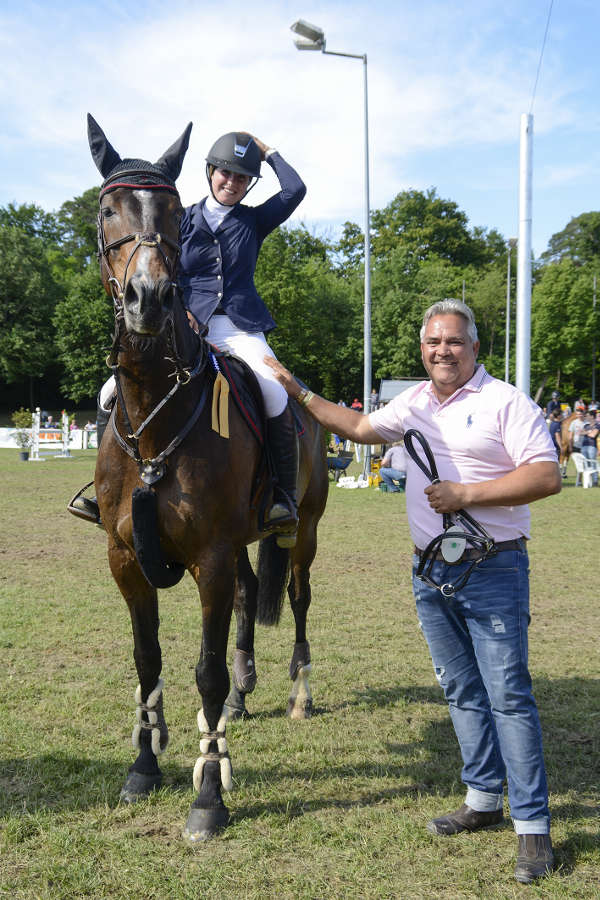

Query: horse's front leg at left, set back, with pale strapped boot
[{"left": 109, "top": 544, "right": 169, "bottom": 803}]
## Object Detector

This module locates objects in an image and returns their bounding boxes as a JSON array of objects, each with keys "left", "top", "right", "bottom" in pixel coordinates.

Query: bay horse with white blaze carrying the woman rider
[{"left": 88, "top": 116, "right": 328, "bottom": 843}]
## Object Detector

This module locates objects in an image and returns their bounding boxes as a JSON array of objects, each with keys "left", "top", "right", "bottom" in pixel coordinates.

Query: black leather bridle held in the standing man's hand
[{"left": 404, "top": 428, "right": 496, "bottom": 599}]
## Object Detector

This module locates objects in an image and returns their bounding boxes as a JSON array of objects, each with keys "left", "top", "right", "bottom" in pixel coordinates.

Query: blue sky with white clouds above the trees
[{"left": 0, "top": 0, "right": 600, "bottom": 256}]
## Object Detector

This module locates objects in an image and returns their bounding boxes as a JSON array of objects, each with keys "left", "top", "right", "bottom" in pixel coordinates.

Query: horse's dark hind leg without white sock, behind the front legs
[{"left": 225, "top": 547, "right": 258, "bottom": 719}]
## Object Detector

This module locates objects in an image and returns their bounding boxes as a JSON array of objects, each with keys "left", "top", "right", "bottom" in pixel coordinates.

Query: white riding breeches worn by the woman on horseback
[{"left": 100, "top": 316, "right": 287, "bottom": 419}]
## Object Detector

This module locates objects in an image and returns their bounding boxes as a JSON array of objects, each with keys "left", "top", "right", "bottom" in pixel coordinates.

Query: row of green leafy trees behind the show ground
[{"left": 0, "top": 187, "right": 600, "bottom": 408}]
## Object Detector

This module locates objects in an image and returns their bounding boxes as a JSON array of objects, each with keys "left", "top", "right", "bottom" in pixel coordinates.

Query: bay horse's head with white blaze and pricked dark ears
[{"left": 88, "top": 115, "right": 192, "bottom": 336}]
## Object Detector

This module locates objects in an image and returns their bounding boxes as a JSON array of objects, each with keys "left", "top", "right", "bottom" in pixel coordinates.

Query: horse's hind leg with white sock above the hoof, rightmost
[{"left": 287, "top": 518, "right": 317, "bottom": 719}]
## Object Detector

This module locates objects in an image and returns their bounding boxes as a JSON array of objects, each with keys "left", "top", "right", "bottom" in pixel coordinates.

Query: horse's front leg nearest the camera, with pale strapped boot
[{"left": 183, "top": 555, "right": 235, "bottom": 844}]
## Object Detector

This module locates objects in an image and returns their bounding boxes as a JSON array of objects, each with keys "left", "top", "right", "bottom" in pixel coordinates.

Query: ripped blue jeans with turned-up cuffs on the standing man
[{"left": 413, "top": 550, "right": 550, "bottom": 834}]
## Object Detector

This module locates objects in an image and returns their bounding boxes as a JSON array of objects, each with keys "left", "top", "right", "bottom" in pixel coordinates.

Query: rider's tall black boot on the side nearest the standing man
[{"left": 265, "top": 406, "right": 298, "bottom": 547}]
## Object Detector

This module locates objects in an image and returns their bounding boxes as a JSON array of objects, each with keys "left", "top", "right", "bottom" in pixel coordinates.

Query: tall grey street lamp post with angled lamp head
[{"left": 291, "top": 19, "right": 372, "bottom": 474}]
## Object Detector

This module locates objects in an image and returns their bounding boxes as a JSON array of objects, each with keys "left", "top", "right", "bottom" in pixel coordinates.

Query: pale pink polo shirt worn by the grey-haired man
[{"left": 369, "top": 365, "right": 556, "bottom": 550}]
